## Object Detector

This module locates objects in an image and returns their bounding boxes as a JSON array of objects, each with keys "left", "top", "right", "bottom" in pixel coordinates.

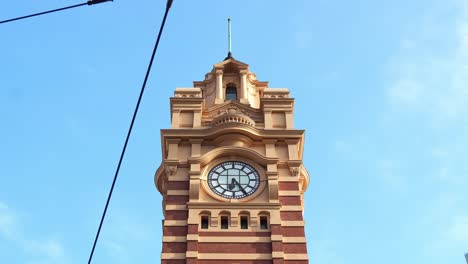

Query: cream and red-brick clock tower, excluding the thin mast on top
[{"left": 154, "top": 56, "right": 309, "bottom": 264}]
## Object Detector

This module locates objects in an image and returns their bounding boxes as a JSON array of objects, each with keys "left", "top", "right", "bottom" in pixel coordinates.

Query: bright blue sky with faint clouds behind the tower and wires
[{"left": 0, "top": 0, "right": 468, "bottom": 264}]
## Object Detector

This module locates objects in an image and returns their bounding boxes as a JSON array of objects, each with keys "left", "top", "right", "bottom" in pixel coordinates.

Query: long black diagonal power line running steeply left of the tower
[{"left": 88, "top": 0, "right": 173, "bottom": 264}]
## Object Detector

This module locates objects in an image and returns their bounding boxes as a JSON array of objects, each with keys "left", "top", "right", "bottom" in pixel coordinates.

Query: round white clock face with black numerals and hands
[{"left": 208, "top": 161, "right": 260, "bottom": 199}]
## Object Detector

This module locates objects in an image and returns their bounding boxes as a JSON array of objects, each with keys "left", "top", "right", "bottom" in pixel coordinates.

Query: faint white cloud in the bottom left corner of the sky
[{"left": 0, "top": 201, "right": 68, "bottom": 264}]
